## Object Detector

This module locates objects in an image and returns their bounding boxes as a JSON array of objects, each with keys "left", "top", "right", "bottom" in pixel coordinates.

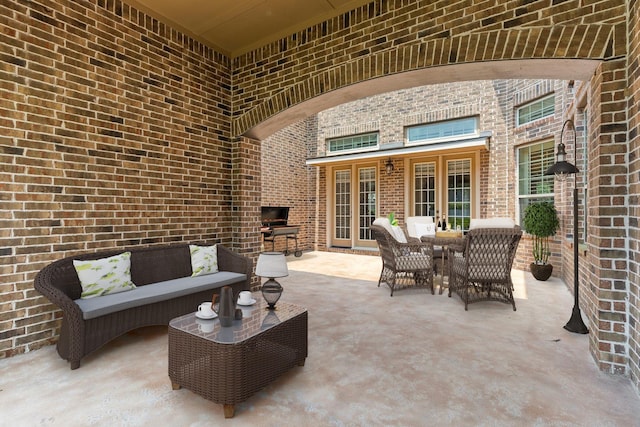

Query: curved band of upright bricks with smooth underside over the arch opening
[{"left": 233, "top": 24, "right": 626, "bottom": 139}]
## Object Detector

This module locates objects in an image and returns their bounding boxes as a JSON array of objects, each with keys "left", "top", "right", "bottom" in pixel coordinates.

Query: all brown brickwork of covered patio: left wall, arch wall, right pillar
[{"left": 0, "top": 0, "right": 640, "bottom": 398}]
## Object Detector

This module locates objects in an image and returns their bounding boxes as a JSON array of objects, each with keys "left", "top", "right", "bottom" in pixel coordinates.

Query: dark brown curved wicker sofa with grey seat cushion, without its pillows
[{"left": 34, "top": 244, "right": 253, "bottom": 369}]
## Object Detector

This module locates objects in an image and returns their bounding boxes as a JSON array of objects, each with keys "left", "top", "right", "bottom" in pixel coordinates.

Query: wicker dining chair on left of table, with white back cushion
[{"left": 371, "top": 218, "right": 434, "bottom": 296}]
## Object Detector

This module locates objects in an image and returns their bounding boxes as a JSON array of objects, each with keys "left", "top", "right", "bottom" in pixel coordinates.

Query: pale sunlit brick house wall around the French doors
[{"left": 300, "top": 79, "right": 571, "bottom": 270}]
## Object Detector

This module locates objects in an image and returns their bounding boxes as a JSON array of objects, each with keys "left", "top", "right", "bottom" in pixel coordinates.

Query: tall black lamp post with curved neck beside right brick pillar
[{"left": 544, "top": 120, "right": 589, "bottom": 334}]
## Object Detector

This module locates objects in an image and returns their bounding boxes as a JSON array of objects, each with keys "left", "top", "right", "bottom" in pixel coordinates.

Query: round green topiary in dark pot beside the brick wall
[{"left": 523, "top": 202, "right": 560, "bottom": 280}]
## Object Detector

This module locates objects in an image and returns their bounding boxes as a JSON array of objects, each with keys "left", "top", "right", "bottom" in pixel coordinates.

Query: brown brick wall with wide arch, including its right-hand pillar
[{"left": 232, "top": 0, "right": 639, "bottom": 388}]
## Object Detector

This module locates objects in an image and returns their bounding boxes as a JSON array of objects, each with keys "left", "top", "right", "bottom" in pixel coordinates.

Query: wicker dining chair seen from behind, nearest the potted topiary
[{"left": 449, "top": 225, "right": 522, "bottom": 311}]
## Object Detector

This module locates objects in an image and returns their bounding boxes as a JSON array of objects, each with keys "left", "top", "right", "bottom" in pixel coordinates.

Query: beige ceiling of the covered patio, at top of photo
[{"left": 128, "top": 0, "right": 371, "bottom": 57}]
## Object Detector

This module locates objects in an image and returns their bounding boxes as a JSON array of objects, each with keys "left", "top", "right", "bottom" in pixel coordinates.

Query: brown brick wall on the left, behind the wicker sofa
[{"left": 0, "top": 1, "right": 233, "bottom": 357}]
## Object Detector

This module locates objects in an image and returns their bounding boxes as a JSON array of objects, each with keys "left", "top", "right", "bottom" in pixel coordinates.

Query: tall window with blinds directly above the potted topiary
[{"left": 518, "top": 140, "right": 555, "bottom": 224}]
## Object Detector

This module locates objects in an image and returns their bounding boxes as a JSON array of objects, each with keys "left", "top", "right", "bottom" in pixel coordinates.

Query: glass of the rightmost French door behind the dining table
[{"left": 447, "top": 159, "right": 471, "bottom": 231}]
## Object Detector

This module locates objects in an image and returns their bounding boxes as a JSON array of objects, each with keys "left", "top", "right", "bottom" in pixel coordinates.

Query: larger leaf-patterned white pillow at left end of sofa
[{"left": 73, "top": 252, "right": 136, "bottom": 299}]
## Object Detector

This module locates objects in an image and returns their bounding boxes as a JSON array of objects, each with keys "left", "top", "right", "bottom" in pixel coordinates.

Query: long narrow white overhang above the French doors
[{"left": 306, "top": 132, "right": 491, "bottom": 166}]
